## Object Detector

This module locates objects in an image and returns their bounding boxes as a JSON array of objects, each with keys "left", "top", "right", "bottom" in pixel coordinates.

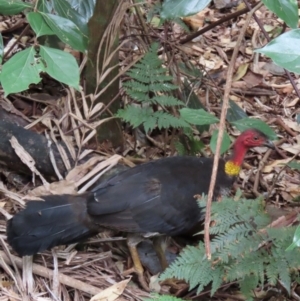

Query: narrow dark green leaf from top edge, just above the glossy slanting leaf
[{"left": 53, "top": 0, "right": 88, "bottom": 38}]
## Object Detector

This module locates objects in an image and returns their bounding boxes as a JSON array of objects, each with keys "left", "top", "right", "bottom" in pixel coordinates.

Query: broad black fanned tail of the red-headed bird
[{"left": 7, "top": 195, "right": 97, "bottom": 256}]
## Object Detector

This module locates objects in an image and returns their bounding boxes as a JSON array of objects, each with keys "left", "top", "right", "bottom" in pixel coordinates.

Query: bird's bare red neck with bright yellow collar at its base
[{"left": 225, "top": 141, "right": 247, "bottom": 177}]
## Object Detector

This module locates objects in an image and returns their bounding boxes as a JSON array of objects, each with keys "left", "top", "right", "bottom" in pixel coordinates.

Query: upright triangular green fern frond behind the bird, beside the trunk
[{"left": 117, "top": 44, "right": 190, "bottom": 132}]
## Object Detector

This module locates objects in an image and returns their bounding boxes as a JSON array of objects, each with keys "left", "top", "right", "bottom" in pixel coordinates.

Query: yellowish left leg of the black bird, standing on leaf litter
[{"left": 127, "top": 235, "right": 150, "bottom": 292}]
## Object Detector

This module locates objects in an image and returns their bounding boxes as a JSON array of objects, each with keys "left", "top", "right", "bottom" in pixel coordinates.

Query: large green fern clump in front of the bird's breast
[{"left": 161, "top": 198, "right": 300, "bottom": 300}]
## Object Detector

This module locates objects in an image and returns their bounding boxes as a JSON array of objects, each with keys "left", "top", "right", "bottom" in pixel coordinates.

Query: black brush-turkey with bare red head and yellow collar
[{"left": 7, "top": 129, "right": 273, "bottom": 288}]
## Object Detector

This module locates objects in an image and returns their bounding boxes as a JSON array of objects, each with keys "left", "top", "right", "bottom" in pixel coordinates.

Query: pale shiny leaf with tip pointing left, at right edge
[{"left": 255, "top": 29, "right": 300, "bottom": 74}]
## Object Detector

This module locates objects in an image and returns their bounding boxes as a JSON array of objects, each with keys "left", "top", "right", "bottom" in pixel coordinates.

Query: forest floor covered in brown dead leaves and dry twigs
[{"left": 0, "top": 0, "right": 300, "bottom": 301}]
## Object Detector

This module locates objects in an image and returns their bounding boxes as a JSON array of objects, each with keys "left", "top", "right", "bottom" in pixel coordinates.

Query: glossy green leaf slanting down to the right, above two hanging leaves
[{"left": 42, "top": 14, "right": 88, "bottom": 52}]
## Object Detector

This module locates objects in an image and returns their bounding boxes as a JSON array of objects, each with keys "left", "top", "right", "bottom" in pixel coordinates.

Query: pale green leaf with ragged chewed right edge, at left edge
[{"left": 0, "top": 47, "right": 45, "bottom": 95}]
